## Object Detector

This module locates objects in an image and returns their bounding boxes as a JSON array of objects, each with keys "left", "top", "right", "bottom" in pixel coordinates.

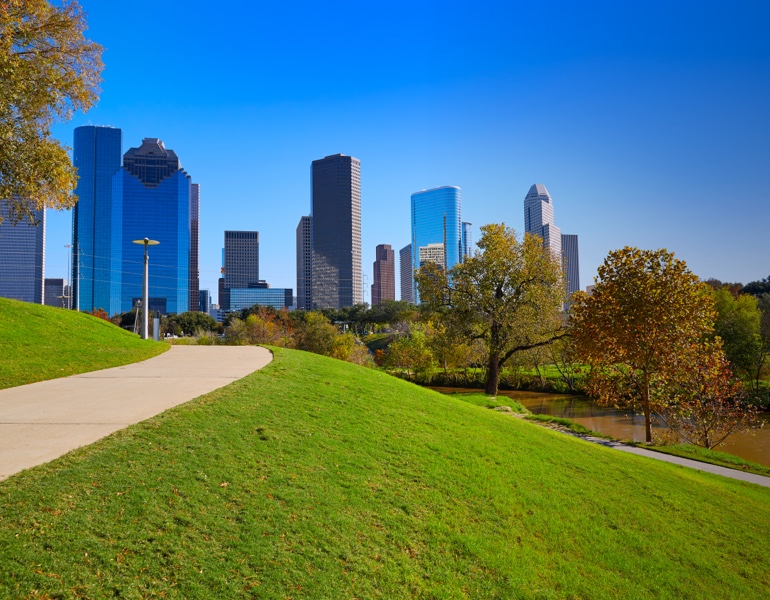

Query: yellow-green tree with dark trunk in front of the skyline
[{"left": 417, "top": 224, "right": 565, "bottom": 395}]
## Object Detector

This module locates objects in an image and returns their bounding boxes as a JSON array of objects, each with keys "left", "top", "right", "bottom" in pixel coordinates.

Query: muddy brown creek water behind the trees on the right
[{"left": 431, "top": 387, "right": 770, "bottom": 467}]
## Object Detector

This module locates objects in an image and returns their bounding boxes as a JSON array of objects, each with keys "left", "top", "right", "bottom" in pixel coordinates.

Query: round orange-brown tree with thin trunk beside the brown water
[{"left": 570, "top": 246, "right": 715, "bottom": 443}]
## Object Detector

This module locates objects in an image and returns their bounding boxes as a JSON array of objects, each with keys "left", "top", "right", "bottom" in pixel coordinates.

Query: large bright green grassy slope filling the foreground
[{"left": 0, "top": 349, "right": 770, "bottom": 599}]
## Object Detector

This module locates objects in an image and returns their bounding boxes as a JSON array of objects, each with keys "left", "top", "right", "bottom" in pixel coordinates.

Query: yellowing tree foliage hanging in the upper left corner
[{"left": 0, "top": 0, "right": 102, "bottom": 222}]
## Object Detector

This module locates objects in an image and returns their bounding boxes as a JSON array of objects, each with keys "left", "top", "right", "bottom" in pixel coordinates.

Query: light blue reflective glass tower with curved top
[{"left": 412, "top": 186, "right": 463, "bottom": 304}]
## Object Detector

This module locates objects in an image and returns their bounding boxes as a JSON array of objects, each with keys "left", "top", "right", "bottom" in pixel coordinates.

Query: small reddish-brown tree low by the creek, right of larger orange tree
[{"left": 663, "top": 340, "right": 758, "bottom": 450}]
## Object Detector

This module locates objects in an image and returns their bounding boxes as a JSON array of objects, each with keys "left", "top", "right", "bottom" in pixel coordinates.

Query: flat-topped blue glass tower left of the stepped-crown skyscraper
[{"left": 72, "top": 125, "right": 121, "bottom": 312}]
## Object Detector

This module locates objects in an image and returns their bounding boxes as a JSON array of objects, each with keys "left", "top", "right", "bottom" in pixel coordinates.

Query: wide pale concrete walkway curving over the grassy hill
[{"left": 0, "top": 346, "right": 273, "bottom": 480}]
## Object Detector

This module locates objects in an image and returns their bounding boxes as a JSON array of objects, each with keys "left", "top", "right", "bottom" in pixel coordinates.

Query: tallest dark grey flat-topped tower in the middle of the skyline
[{"left": 311, "top": 154, "right": 363, "bottom": 308}]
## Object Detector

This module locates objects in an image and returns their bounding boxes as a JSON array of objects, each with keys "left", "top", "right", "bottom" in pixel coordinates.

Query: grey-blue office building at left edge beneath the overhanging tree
[{"left": 0, "top": 202, "right": 45, "bottom": 304}]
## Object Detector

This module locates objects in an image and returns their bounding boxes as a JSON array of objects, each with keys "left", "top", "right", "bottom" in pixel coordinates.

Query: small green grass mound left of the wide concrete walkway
[{"left": 0, "top": 298, "right": 168, "bottom": 389}]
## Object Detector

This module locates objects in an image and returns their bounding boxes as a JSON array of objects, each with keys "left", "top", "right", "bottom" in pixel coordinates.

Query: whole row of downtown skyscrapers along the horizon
[{"left": 0, "top": 134, "right": 580, "bottom": 312}]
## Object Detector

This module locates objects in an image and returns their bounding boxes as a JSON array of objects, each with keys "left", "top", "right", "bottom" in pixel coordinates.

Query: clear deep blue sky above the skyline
[{"left": 46, "top": 0, "right": 770, "bottom": 301}]
